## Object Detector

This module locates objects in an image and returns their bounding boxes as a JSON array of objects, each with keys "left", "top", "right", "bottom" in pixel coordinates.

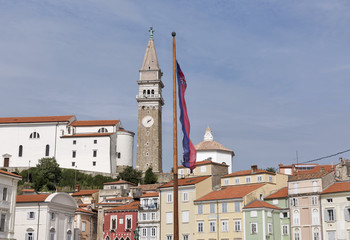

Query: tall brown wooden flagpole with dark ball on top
[{"left": 171, "top": 32, "right": 179, "bottom": 240}]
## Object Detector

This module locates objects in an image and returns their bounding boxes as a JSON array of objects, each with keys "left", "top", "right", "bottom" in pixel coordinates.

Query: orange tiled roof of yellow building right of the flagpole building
[{"left": 195, "top": 184, "right": 265, "bottom": 202}]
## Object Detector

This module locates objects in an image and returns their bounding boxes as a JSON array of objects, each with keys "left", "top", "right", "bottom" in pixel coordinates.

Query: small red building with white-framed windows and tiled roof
[{"left": 103, "top": 201, "right": 140, "bottom": 240}]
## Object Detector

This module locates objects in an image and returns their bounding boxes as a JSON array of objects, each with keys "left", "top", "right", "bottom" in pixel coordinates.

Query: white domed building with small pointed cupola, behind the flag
[{"left": 195, "top": 127, "right": 235, "bottom": 173}]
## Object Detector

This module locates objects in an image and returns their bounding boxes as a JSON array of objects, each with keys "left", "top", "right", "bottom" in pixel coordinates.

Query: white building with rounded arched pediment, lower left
[{"left": 15, "top": 192, "right": 78, "bottom": 240}]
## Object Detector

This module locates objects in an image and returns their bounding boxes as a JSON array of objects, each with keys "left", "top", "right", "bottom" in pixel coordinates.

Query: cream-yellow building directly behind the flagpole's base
[{"left": 159, "top": 176, "right": 212, "bottom": 240}]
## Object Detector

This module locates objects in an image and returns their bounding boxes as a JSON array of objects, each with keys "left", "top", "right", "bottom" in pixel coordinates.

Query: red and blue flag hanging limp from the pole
[{"left": 176, "top": 61, "right": 197, "bottom": 172}]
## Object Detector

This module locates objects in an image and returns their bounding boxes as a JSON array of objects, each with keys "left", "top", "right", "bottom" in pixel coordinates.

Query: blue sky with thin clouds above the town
[{"left": 0, "top": 0, "right": 350, "bottom": 171}]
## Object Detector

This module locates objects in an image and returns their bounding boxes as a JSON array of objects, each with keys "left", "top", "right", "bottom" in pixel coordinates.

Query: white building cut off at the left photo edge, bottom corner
[{"left": 0, "top": 170, "right": 21, "bottom": 239}]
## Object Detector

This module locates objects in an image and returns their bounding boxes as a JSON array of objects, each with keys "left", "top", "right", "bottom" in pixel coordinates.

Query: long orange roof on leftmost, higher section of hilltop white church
[{"left": 0, "top": 115, "right": 75, "bottom": 124}]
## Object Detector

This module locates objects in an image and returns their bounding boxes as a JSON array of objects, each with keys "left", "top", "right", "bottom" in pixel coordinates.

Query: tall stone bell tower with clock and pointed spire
[{"left": 136, "top": 28, "right": 164, "bottom": 172}]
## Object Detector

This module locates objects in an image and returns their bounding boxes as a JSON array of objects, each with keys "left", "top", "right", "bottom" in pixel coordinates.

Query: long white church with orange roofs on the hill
[{"left": 0, "top": 115, "right": 134, "bottom": 174}]
